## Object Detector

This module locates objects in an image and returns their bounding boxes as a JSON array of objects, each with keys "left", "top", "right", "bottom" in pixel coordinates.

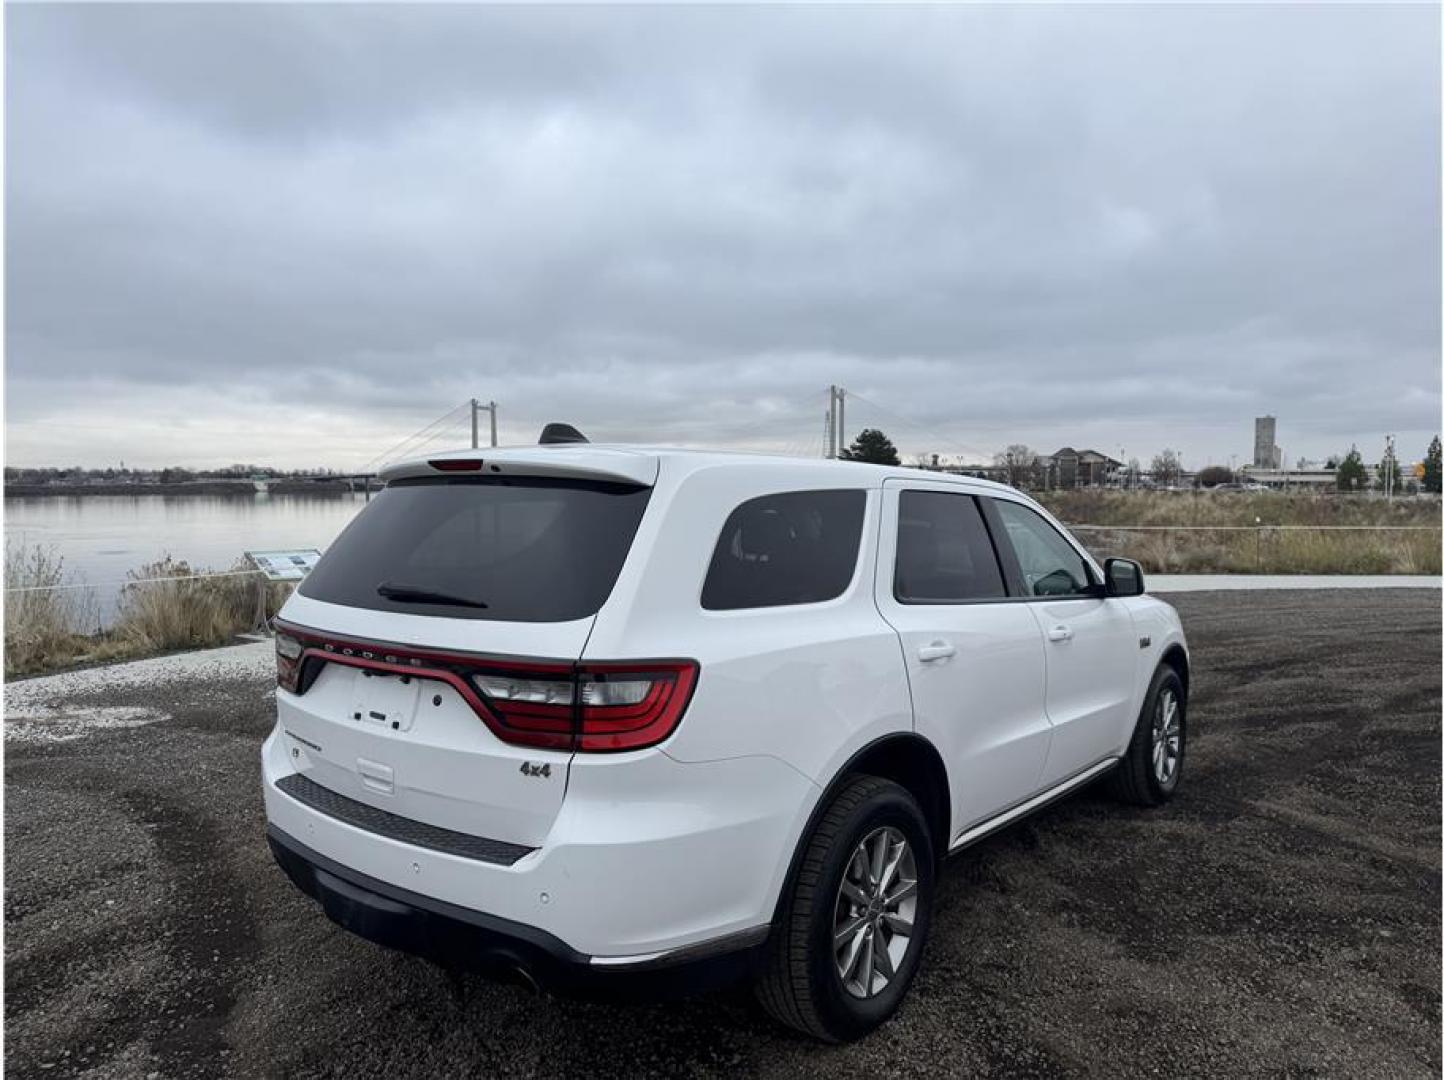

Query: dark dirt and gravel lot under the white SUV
[{"left": 4, "top": 589, "right": 1441, "bottom": 1080}]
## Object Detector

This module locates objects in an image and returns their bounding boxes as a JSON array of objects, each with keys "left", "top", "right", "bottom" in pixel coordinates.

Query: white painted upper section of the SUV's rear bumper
[{"left": 261, "top": 731, "right": 816, "bottom": 967}]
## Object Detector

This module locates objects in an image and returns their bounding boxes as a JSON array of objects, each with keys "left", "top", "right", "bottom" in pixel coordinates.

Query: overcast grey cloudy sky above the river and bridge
[{"left": 6, "top": 4, "right": 1441, "bottom": 468}]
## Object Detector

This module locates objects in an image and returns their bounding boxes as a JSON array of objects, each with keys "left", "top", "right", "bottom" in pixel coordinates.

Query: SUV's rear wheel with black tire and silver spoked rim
[{"left": 755, "top": 775, "right": 936, "bottom": 1042}]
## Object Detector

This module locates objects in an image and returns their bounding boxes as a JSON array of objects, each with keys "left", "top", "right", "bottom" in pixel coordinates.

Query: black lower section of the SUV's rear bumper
[{"left": 267, "top": 824, "right": 767, "bottom": 998}]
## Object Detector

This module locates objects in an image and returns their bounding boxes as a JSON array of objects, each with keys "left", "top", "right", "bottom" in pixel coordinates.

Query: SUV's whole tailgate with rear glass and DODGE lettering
[{"left": 277, "top": 476, "right": 650, "bottom": 846}]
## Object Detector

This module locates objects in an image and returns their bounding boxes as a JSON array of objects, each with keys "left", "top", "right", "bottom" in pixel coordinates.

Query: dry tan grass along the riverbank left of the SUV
[{"left": 4, "top": 544, "right": 290, "bottom": 677}]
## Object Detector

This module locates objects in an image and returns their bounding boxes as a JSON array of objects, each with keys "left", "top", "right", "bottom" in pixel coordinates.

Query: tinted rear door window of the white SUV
[{"left": 892, "top": 491, "right": 1005, "bottom": 604}]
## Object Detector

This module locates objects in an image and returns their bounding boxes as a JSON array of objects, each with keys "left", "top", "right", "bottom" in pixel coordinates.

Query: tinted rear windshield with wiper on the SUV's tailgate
[{"left": 299, "top": 476, "right": 651, "bottom": 622}]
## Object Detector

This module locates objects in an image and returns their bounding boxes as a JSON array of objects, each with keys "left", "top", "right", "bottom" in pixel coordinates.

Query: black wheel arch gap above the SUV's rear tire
[{"left": 773, "top": 732, "right": 953, "bottom": 923}]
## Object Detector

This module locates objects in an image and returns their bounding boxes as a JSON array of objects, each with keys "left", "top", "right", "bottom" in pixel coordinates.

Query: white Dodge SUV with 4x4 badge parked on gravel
[{"left": 261, "top": 442, "right": 1188, "bottom": 1040}]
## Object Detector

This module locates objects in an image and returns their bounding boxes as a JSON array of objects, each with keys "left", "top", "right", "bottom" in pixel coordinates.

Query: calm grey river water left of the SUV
[{"left": 4, "top": 494, "right": 365, "bottom": 621}]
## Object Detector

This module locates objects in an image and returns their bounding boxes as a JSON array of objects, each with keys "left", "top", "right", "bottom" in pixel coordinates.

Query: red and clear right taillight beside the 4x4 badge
[{"left": 472, "top": 661, "right": 697, "bottom": 752}]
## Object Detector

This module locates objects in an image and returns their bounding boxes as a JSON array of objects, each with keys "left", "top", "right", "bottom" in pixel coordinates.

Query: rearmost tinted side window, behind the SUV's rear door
[{"left": 702, "top": 491, "right": 868, "bottom": 611}]
